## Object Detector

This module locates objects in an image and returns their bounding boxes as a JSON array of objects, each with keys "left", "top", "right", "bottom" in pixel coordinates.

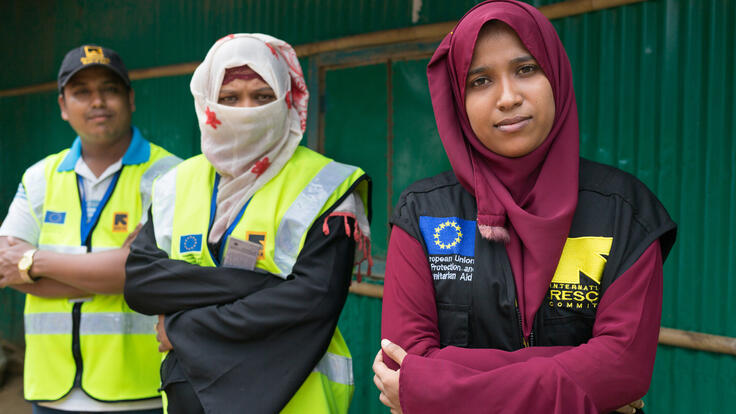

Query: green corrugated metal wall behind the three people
[{"left": 0, "top": 0, "right": 736, "bottom": 413}]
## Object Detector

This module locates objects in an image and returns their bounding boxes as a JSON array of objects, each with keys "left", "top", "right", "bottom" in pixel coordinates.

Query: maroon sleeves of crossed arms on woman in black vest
[{"left": 383, "top": 227, "right": 662, "bottom": 413}]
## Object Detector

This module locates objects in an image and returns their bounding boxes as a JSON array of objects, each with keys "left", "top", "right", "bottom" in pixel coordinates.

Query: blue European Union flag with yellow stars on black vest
[{"left": 419, "top": 216, "right": 475, "bottom": 257}]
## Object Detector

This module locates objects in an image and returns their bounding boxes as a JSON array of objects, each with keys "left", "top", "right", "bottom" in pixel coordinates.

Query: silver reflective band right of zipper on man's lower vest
[{"left": 79, "top": 312, "right": 158, "bottom": 335}]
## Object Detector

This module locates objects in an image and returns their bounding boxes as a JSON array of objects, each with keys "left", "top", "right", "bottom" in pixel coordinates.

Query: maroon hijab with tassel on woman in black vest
[{"left": 427, "top": 0, "right": 579, "bottom": 337}]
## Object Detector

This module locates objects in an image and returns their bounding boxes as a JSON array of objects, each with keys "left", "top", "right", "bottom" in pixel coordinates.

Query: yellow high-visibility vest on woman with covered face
[{"left": 162, "top": 147, "right": 368, "bottom": 413}]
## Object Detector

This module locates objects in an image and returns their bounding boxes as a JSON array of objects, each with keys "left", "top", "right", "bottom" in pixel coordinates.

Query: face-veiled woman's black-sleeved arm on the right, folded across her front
[{"left": 166, "top": 213, "right": 355, "bottom": 342}]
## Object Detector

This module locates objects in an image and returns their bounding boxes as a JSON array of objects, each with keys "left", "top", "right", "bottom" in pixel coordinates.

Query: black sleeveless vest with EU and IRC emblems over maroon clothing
[{"left": 391, "top": 159, "right": 676, "bottom": 351}]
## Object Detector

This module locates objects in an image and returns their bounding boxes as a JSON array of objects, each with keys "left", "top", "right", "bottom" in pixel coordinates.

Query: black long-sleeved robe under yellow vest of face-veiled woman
[{"left": 125, "top": 205, "right": 355, "bottom": 414}]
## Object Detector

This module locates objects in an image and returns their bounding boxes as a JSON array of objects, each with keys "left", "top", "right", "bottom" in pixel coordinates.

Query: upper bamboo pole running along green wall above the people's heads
[{"left": 0, "top": 0, "right": 647, "bottom": 98}]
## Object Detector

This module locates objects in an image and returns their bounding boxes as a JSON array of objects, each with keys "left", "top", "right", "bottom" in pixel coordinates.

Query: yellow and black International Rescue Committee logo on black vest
[{"left": 547, "top": 237, "right": 613, "bottom": 310}]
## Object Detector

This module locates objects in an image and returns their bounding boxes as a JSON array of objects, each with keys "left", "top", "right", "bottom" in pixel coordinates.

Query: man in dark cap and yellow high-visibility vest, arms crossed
[{"left": 0, "top": 45, "right": 180, "bottom": 414}]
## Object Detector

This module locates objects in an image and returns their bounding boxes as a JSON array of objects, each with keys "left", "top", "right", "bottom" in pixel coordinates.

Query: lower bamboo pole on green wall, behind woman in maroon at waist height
[{"left": 350, "top": 281, "right": 736, "bottom": 355}]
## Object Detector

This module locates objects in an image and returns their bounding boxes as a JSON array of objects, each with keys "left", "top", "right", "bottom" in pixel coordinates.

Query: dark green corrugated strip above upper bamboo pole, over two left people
[{"left": 0, "top": 0, "right": 420, "bottom": 89}]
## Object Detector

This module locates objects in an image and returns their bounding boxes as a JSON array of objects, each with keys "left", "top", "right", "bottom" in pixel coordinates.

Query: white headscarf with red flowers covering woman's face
[{"left": 190, "top": 33, "right": 309, "bottom": 243}]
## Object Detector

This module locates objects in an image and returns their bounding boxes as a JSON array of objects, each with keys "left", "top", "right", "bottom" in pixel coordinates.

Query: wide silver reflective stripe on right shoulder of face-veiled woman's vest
[{"left": 273, "top": 161, "right": 357, "bottom": 277}]
